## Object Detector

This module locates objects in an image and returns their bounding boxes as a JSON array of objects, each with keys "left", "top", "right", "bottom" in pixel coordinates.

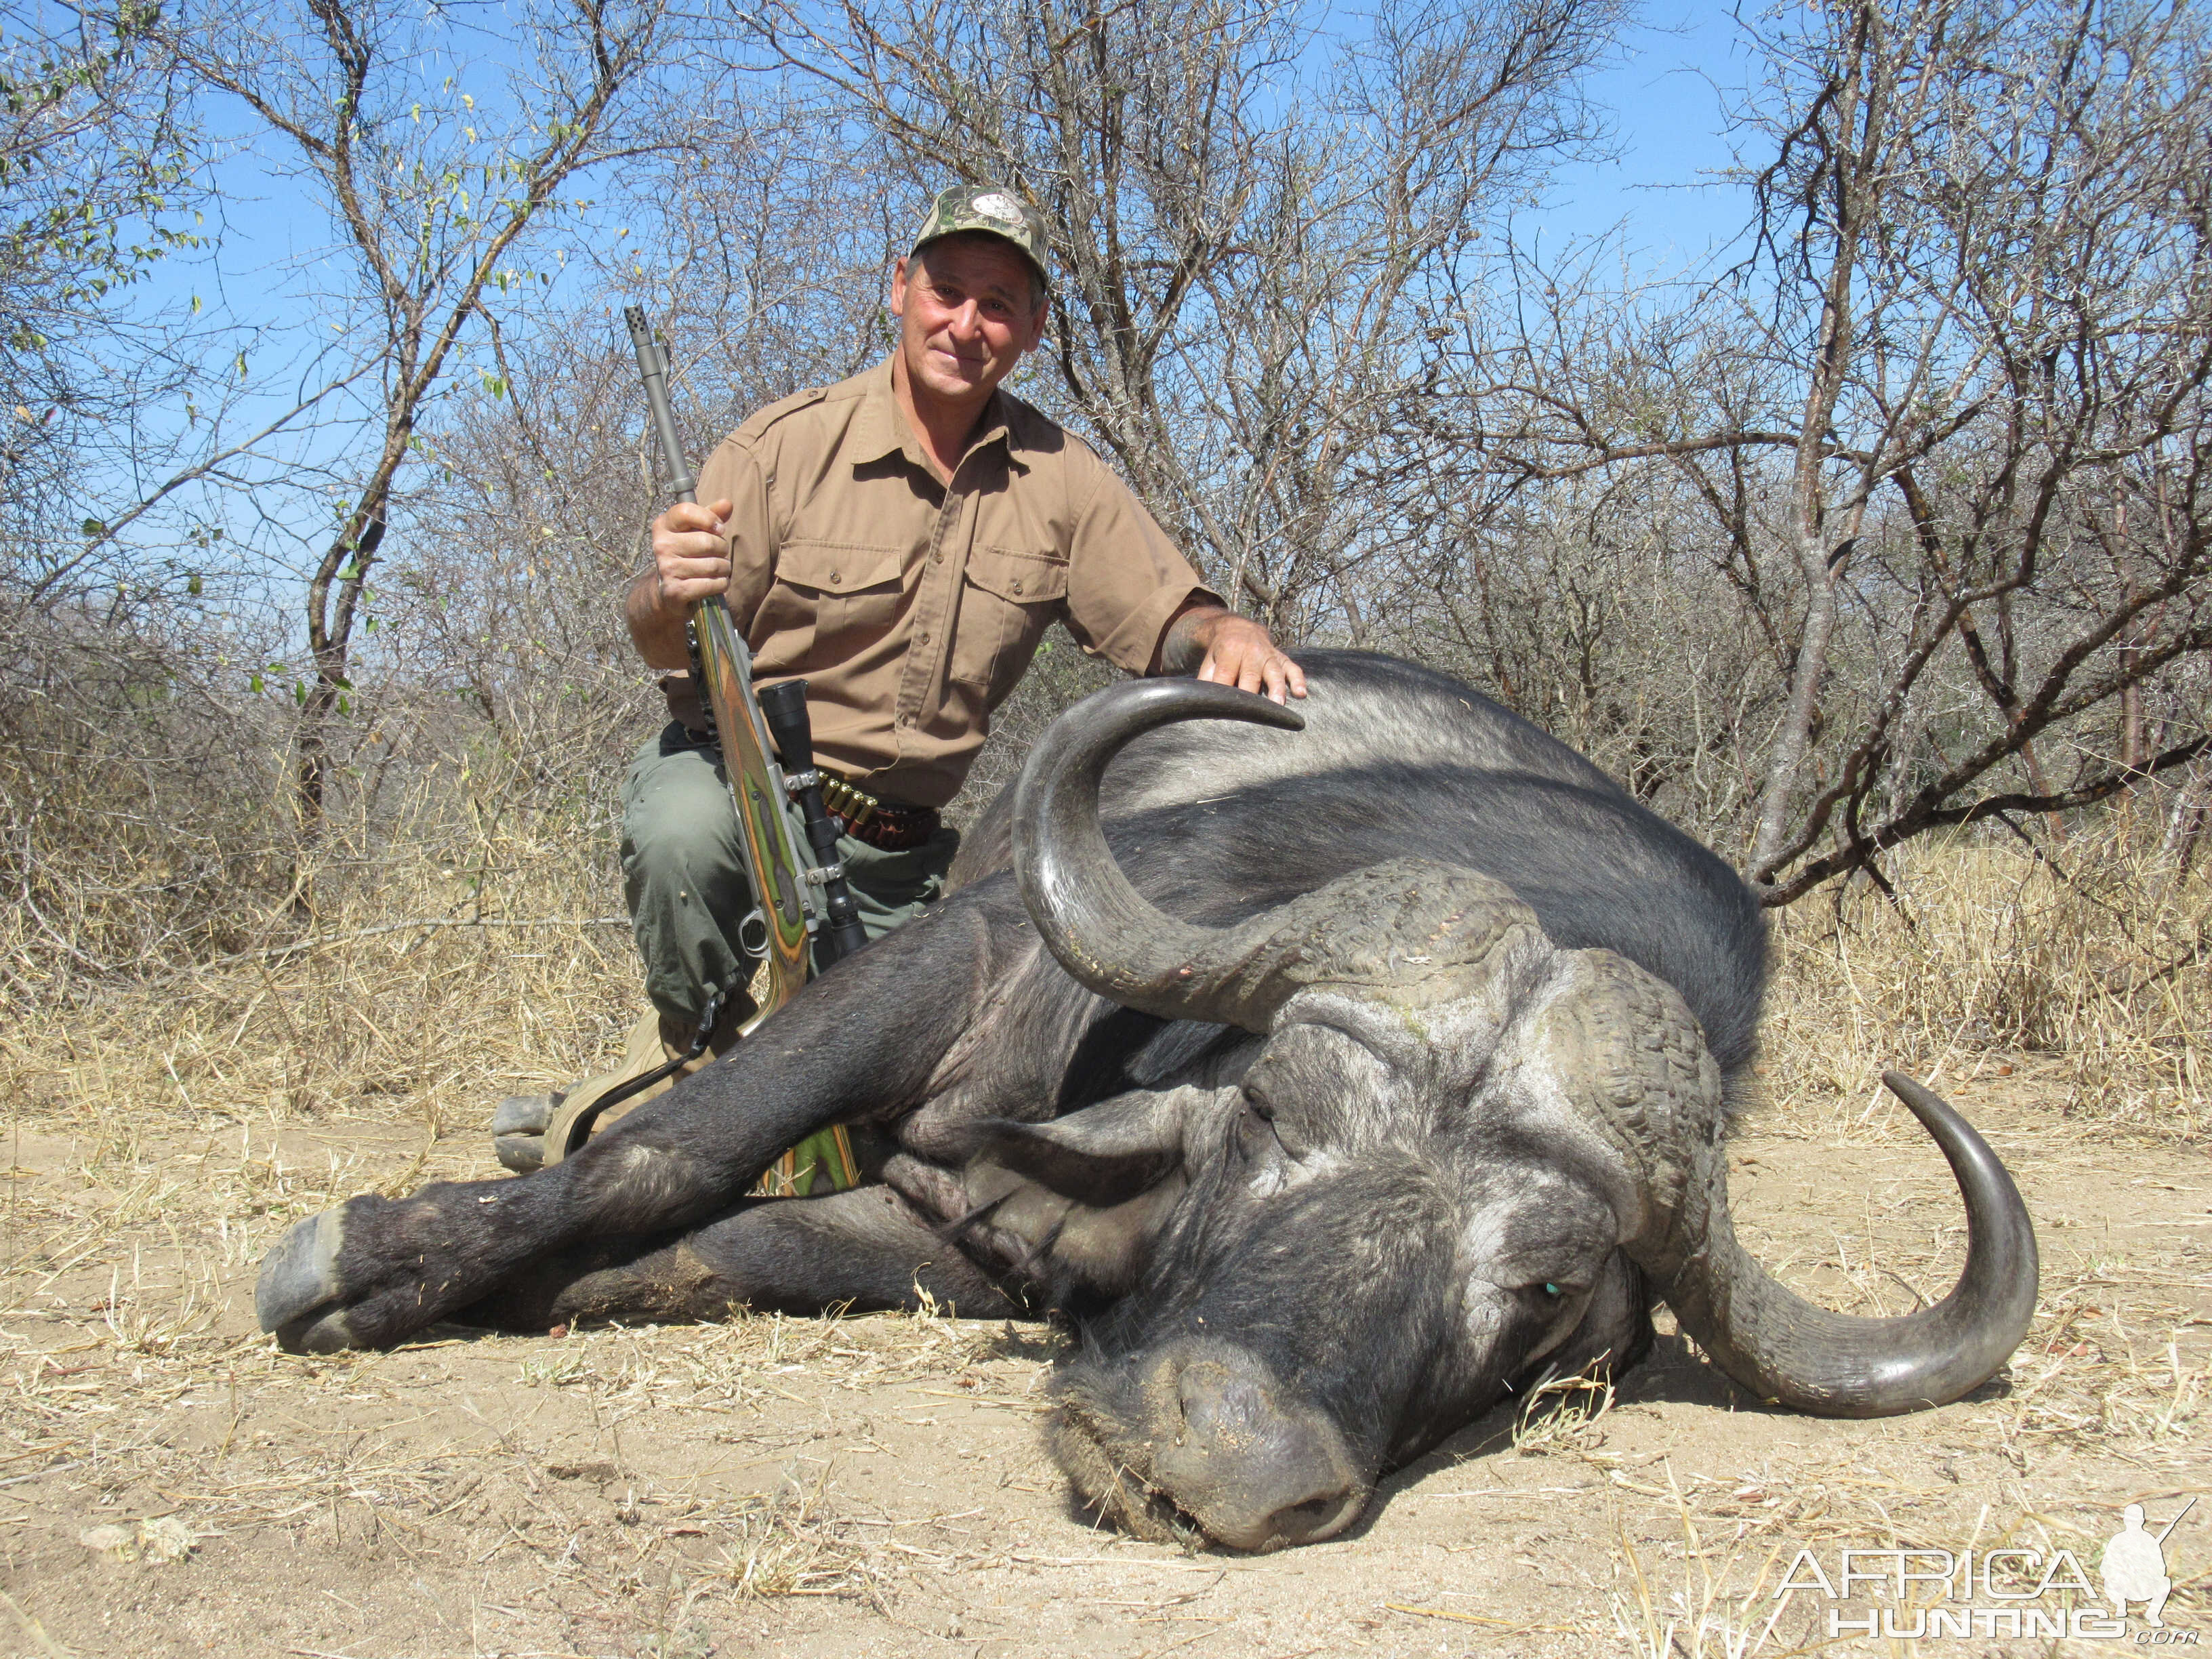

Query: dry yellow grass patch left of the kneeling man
[{"left": 0, "top": 809, "right": 642, "bottom": 1143}]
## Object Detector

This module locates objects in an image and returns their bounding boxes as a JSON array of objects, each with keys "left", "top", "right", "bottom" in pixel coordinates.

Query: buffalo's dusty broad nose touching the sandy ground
[{"left": 1155, "top": 1358, "right": 1363, "bottom": 1551}]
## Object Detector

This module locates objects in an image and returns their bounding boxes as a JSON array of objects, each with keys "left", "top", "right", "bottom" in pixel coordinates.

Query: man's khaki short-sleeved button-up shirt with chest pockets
[{"left": 663, "top": 361, "right": 1221, "bottom": 807}]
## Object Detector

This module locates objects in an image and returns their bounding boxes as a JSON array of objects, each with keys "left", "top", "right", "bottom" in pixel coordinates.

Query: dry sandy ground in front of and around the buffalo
[{"left": 0, "top": 1069, "right": 2212, "bottom": 1659}]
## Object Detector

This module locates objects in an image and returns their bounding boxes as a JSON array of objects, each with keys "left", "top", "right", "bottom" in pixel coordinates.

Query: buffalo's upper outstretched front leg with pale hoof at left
[{"left": 254, "top": 900, "right": 989, "bottom": 1354}]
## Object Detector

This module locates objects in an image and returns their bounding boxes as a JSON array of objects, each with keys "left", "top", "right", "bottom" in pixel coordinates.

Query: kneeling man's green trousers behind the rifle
[{"left": 621, "top": 721, "right": 960, "bottom": 1031}]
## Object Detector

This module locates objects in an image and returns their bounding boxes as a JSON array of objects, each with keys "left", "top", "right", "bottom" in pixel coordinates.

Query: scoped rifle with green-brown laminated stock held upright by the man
[{"left": 548, "top": 305, "right": 867, "bottom": 1188}]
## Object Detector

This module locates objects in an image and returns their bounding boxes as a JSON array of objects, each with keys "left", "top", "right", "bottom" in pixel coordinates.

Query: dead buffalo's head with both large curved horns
[{"left": 969, "top": 681, "right": 2035, "bottom": 1551}]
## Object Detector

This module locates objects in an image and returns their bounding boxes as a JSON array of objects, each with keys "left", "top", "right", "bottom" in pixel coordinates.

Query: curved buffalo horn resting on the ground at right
[{"left": 1631, "top": 1071, "right": 2037, "bottom": 1418}]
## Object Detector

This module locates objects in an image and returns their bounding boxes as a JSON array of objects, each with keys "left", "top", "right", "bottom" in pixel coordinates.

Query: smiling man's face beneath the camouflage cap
[{"left": 891, "top": 232, "right": 1044, "bottom": 413}]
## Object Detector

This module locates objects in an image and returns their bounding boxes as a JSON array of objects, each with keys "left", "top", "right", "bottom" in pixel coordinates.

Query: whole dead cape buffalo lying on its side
[{"left": 257, "top": 653, "right": 2037, "bottom": 1549}]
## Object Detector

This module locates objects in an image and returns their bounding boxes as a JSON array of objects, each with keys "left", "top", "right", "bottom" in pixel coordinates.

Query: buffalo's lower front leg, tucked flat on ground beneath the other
[{"left": 453, "top": 1186, "right": 1024, "bottom": 1332}]
